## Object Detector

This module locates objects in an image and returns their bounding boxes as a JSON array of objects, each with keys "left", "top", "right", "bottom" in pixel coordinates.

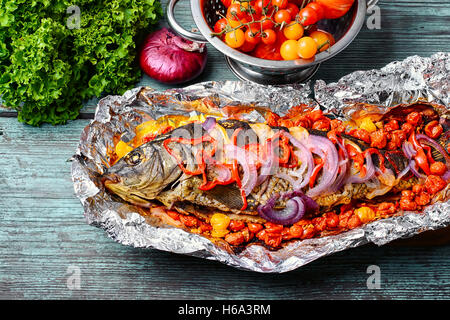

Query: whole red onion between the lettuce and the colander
[{"left": 140, "top": 28, "right": 207, "bottom": 84}]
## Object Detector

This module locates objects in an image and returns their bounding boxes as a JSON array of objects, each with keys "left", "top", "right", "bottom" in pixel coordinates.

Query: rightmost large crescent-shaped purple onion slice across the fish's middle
[{"left": 307, "top": 135, "right": 340, "bottom": 198}]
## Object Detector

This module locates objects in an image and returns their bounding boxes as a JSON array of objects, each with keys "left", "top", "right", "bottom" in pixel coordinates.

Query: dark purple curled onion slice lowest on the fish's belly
[{"left": 257, "top": 195, "right": 306, "bottom": 225}]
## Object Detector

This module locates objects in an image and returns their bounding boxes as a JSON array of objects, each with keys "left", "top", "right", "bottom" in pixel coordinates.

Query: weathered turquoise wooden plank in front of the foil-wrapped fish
[{"left": 0, "top": 118, "right": 450, "bottom": 299}]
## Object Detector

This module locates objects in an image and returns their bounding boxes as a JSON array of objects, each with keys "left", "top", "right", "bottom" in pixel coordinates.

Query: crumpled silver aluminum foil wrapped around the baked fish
[{"left": 72, "top": 53, "right": 450, "bottom": 273}]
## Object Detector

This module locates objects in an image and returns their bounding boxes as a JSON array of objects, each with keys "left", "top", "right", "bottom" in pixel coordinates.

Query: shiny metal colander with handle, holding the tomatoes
[{"left": 167, "top": 0, "right": 367, "bottom": 84}]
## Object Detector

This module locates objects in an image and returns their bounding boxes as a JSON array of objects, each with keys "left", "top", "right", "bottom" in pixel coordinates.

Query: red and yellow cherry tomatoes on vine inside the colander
[{"left": 212, "top": 0, "right": 355, "bottom": 60}]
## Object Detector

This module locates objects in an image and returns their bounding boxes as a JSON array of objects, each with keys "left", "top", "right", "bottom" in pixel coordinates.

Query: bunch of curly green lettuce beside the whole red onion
[{"left": 0, "top": 0, "right": 162, "bottom": 126}]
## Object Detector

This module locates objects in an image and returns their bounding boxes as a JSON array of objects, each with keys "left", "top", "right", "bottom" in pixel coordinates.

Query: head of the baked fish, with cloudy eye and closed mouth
[{"left": 102, "top": 143, "right": 182, "bottom": 207}]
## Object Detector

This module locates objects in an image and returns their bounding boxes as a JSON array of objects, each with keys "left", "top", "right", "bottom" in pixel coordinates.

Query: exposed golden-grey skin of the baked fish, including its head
[{"left": 103, "top": 120, "right": 410, "bottom": 217}]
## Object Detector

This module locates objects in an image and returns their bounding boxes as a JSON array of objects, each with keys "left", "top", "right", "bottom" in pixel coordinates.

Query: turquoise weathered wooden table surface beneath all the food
[{"left": 0, "top": 0, "right": 450, "bottom": 299}]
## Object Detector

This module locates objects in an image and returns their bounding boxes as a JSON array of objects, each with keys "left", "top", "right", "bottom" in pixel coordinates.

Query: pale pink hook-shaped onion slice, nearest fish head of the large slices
[{"left": 224, "top": 144, "right": 258, "bottom": 196}]
